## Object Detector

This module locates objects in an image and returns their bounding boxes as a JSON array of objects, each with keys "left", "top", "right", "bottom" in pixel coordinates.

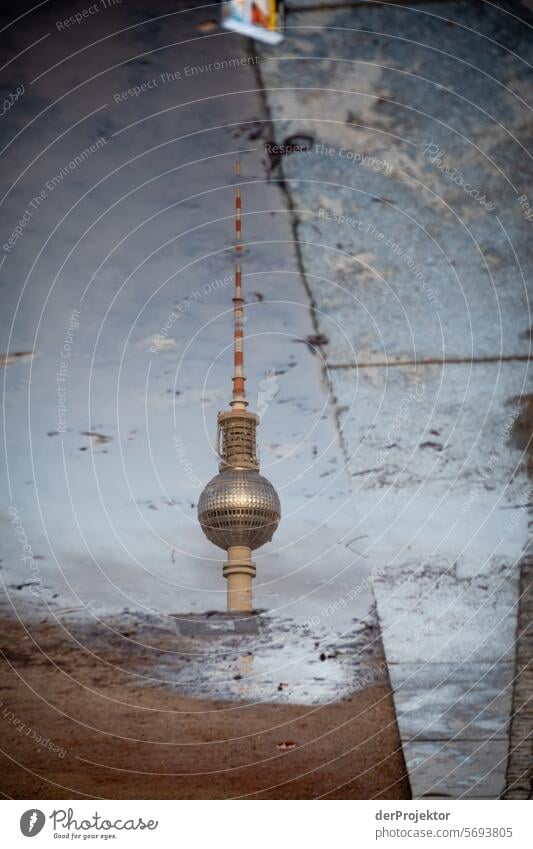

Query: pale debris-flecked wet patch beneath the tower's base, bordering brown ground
[{"left": 149, "top": 617, "right": 386, "bottom": 705}]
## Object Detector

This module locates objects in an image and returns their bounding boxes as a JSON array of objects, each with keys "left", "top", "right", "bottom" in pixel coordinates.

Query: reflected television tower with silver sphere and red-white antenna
[{"left": 198, "top": 162, "right": 280, "bottom": 613}]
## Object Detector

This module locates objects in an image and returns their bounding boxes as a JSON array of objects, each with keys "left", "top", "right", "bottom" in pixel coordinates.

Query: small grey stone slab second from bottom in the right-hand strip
[{"left": 389, "top": 662, "right": 514, "bottom": 742}]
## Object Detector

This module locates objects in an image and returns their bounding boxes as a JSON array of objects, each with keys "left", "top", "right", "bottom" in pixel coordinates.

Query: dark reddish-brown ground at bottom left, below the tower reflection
[{"left": 0, "top": 617, "right": 409, "bottom": 799}]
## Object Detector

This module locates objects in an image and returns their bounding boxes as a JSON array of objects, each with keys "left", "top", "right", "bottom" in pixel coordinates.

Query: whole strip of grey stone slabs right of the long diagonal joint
[{"left": 260, "top": 2, "right": 533, "bottom": 797}]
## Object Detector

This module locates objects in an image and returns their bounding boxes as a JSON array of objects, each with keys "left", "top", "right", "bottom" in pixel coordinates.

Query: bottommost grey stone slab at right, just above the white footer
[{"left": 403, "top": 740, "right": 507, "bottom": 799}]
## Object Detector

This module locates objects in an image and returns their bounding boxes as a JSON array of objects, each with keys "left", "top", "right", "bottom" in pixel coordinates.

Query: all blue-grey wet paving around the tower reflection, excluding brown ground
[{"left": 0, "top": 2, "right": 532, "bottom": 798}]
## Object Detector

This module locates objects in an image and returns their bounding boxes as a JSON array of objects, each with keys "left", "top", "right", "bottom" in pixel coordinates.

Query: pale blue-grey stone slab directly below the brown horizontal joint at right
[{"left": 331, "top": 354, "right": 530, "bottom": 663}]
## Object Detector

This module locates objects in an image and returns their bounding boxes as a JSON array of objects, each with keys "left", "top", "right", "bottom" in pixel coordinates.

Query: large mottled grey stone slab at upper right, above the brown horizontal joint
[{"left": 261, "top": 3, "right": 533, "bottom": 363}]
